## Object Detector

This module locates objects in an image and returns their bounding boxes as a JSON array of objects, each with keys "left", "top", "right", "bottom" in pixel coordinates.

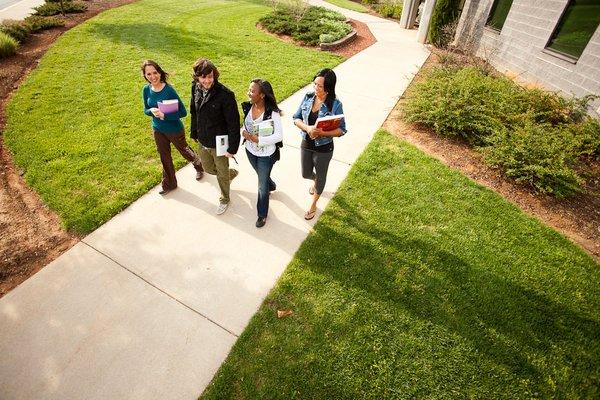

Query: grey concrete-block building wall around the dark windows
[{"left": 456, "top": 0, "right": 600, "bottom": 113}]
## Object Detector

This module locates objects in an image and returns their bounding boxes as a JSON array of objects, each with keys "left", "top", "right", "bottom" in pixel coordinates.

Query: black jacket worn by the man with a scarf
[{"left": 190, "top": 81, "right": 240, "bottom": 154}]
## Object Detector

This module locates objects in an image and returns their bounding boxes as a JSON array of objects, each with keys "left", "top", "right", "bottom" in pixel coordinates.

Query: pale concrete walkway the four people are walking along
[{"left": 0, "top": 1, "right": 428, "bottom": 400}]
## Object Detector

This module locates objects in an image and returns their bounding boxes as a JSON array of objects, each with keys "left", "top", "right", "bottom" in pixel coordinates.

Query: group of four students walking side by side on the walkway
[{"left": 141, "top": 58, "right": 346, "bottom": 228}]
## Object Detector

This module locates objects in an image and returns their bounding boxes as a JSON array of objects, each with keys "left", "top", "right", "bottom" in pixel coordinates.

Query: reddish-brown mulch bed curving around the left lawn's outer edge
[{"left": 0, "top": 0, "right": 135, "bottom": 297}]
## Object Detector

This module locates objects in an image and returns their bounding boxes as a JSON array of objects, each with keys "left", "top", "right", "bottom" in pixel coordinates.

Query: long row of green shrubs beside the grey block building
[{"left": 404, "top": 66, "right": 600, "bottom": 197}]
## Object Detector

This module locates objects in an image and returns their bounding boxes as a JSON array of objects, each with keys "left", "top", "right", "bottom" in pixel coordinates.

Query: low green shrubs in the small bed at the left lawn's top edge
[{"left": 259, "top": 6, "right": 352, "bottom": 46}]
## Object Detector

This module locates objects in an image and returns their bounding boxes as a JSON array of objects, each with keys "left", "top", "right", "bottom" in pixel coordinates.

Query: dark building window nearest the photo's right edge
[{"left": 547, "top": 0, "right": 600, "bottom": 59}]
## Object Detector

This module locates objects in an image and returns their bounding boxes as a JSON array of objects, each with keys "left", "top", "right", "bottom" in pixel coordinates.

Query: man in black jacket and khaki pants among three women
[{"left": 190, "top": 58, "right": 240, "bottom": 214}]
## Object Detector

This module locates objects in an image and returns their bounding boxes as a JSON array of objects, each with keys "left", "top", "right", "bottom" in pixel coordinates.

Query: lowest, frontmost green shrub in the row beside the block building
[{"left": 483, "top": 121, "right": 584, "bottom": 197}]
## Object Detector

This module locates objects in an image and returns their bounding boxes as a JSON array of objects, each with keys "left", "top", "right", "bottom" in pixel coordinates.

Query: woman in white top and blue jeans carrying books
[{"left": 242, "top": 79, "right": 283, "bottom": 228}]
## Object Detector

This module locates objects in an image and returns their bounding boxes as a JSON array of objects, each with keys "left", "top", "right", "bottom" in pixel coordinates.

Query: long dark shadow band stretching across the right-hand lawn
[{"left": 296, "top": 194, "right": 600, "bottom": 394}]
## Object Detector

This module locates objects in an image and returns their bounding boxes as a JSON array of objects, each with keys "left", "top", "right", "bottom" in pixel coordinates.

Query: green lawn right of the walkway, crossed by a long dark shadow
[{"left": 202, "top": 131, "right": 600, "bottom": 400}]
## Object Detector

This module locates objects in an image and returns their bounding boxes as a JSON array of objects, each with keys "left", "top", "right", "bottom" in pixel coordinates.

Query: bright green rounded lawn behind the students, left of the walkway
[{"left": 4, "top": 0, "right": 342, "bottom": 233}]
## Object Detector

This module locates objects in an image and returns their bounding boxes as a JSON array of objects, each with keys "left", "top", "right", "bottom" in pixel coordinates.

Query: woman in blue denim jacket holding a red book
[{"left": 293, "top": 68, "right": 346, "bottom": 220}]
